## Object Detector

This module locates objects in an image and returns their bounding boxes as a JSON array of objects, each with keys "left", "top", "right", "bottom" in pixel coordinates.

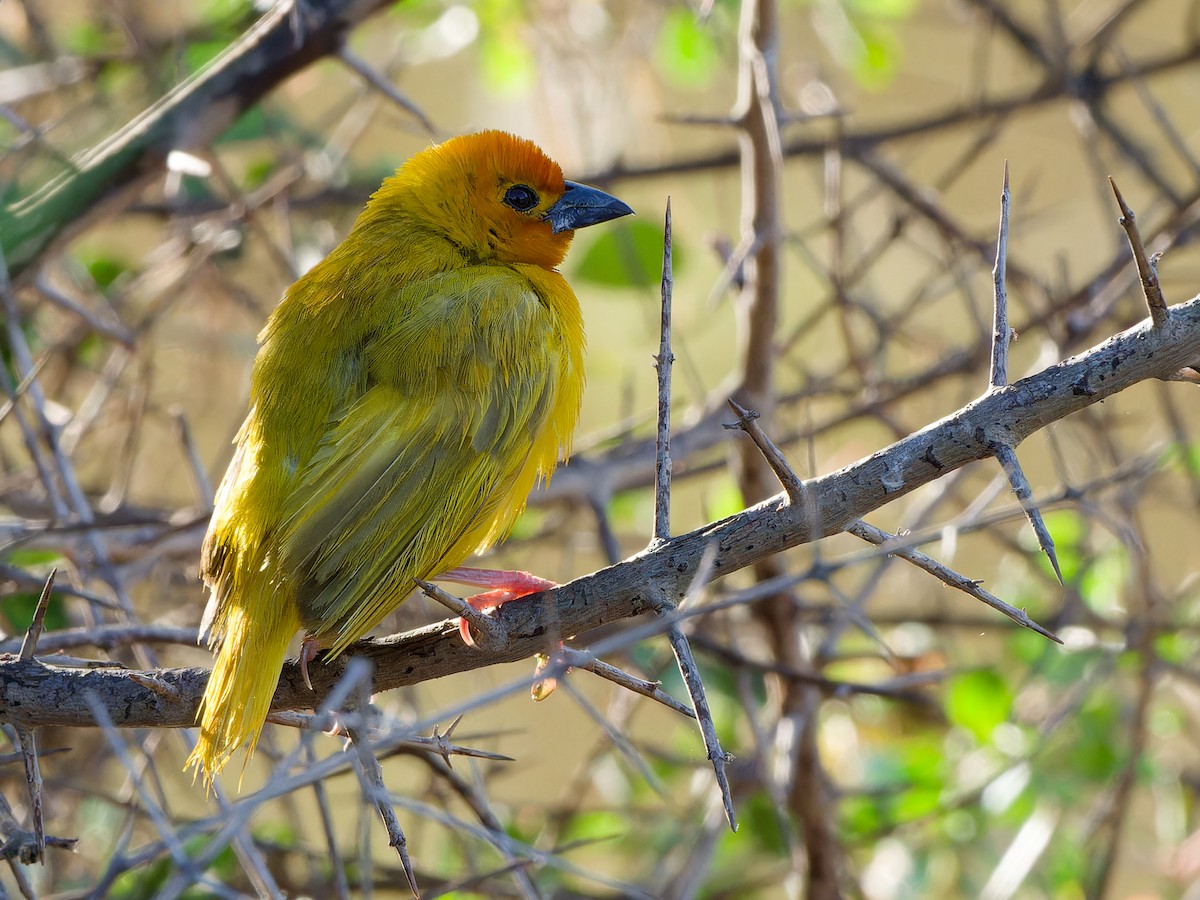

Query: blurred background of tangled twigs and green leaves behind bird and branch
[{"left": 0, "top": 0, "right": 1200, "bottom": 899}]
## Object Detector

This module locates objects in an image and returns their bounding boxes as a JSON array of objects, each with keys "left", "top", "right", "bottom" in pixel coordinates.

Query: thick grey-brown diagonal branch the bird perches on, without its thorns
[{"left": 9, "top": 286, "right": 1200, "bottom": 727}]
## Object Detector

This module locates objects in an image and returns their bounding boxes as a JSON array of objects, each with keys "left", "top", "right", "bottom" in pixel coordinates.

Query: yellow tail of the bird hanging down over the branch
[{"left": 186, "top": 602, "right": 300, "bottom": 784}]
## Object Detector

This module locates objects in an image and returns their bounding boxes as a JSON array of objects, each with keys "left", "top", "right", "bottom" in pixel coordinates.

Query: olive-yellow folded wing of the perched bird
[{"left": 278, "top": 268, "right": 577, "bottom": 650}]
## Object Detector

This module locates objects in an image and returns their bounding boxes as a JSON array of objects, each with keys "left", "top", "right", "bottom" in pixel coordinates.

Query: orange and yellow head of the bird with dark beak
[{"left": 372, "top": 131, "right": 634, "bottom": 269}]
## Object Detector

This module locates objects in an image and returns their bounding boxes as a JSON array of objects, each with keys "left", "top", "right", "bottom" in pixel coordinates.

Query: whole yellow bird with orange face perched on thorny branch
[{"left": 188, "top": 131, "right": 632, "bottom": 781}]
